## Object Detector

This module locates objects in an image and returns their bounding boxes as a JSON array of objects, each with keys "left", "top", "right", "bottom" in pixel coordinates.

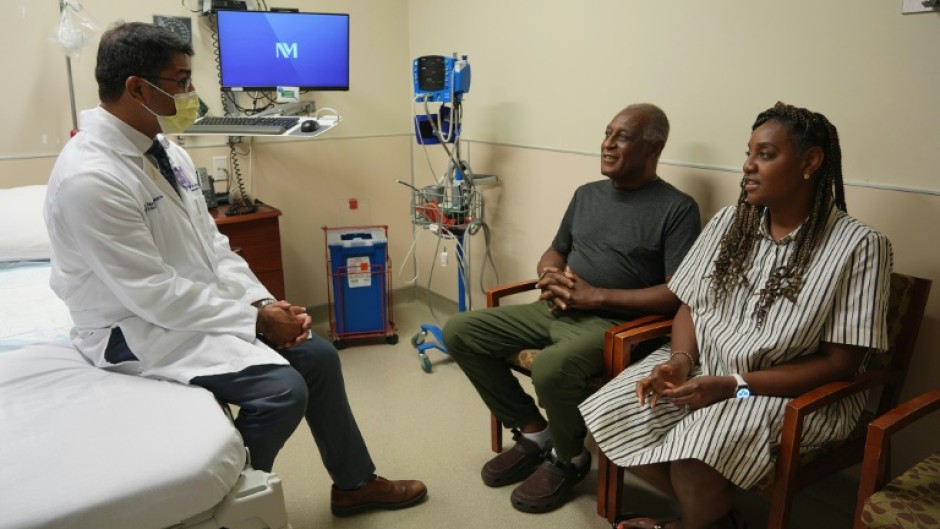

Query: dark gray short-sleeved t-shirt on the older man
[{"left": 552, "top": 179, "right": 701, "bottom": 289}]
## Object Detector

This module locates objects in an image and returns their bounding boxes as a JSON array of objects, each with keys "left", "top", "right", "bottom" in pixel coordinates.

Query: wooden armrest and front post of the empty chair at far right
[{"left": 855, "top": 390, "right": 940, "bottom": 520}]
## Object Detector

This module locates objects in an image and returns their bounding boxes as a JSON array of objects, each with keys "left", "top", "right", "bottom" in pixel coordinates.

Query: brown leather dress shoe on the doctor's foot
[{"left": 330, "top": 476, "right": 428, "bottom": 516}]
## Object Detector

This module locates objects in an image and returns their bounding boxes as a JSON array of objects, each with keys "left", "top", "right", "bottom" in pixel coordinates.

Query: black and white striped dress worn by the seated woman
[{"left": 580, "top": 207, "right": 892, "bottom": 488}]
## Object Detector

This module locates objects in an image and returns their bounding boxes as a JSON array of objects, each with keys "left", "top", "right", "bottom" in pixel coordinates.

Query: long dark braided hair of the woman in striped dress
[{"left": 711, "top": 102, "right": 846, "bottom": 327}]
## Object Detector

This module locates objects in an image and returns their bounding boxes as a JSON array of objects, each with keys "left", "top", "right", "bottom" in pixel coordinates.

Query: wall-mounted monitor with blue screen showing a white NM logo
[{"left": 217, "top": 11, "right": 349, "bottom": 90}]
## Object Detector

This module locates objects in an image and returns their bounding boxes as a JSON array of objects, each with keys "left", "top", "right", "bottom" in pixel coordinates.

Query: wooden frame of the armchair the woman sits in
[{"left": 597, "top": 274, "right": 931, "bottom": 529}]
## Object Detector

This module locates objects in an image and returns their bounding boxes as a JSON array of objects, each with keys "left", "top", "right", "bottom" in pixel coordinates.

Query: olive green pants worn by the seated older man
[{"left": 444, "top": 301, "right": 624, "bottom": 462}]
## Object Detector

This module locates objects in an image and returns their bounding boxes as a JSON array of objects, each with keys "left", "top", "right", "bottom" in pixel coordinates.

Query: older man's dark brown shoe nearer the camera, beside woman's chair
[{"left": 511, "top": 452, "right": 591, "bottom": 513}]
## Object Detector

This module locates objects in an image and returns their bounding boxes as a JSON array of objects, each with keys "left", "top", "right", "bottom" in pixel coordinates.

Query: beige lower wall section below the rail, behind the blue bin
[{"left": 252, "top": 136, "right": 412, "bottom": 305}]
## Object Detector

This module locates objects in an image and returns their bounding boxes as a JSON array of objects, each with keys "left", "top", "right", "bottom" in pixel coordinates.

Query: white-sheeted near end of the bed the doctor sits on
[{"left": 0, "top": 343, "right": 245, "bottom": 529}]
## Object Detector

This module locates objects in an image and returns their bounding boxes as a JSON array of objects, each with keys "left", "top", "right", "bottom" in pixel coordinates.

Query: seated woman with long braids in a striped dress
[{"left": 580, "top": 103, "right": 892, "bottom": 529}]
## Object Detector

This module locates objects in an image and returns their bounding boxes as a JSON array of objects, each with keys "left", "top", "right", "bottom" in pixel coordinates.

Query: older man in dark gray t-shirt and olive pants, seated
[{"left": 444, "top": 104, "right": 701, "bottom": 512}]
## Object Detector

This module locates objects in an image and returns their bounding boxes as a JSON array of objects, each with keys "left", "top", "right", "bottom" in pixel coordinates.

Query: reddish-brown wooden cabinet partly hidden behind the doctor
[{"left": 209, "top": 205, "right": 284, "bottom": 299}]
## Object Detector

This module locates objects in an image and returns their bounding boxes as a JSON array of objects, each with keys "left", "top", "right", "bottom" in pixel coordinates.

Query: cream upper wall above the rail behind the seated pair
[{"left": 409, "top": 0, "right": 940, "bottom": 190}]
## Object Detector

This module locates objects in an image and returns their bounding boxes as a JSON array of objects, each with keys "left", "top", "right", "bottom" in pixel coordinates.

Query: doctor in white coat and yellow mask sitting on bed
[{"left": 45, "top": 23, "right": 426, "bottom": 516}]
